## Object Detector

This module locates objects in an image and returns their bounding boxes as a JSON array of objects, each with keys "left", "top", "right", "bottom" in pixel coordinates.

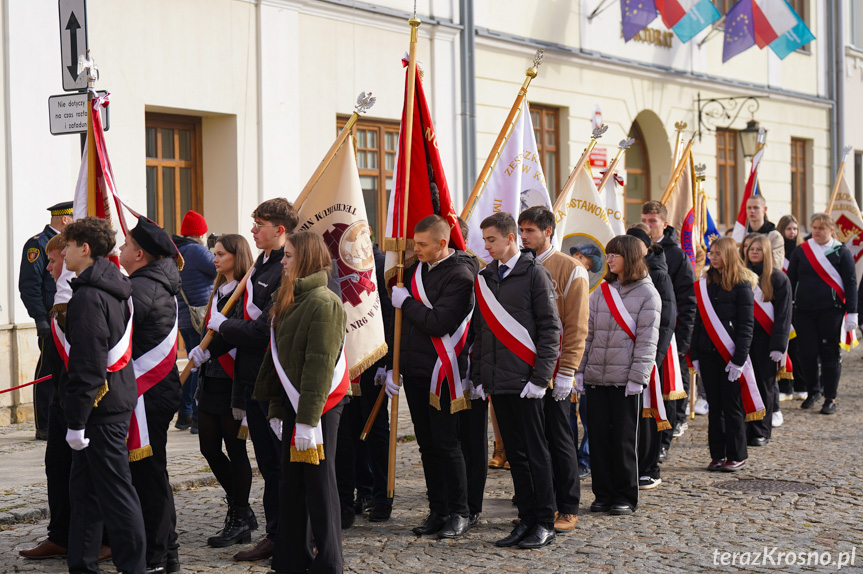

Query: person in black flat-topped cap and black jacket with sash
[{"left": 120, "top": 217, "right": 181, "bottom": 574}]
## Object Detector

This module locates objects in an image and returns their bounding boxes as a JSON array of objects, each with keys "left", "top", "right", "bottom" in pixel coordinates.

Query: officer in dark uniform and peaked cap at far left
[{"left": 18, "top": 201, "right": 72, "bottom": 440}]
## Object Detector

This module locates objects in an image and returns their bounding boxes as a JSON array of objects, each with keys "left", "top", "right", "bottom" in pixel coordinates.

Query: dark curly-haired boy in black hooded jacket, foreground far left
[{"left": 63, "top": 217, "right": 146, "bottom": 573}]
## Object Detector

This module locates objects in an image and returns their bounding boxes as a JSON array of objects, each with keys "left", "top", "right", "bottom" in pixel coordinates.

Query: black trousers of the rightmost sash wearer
[{"left": 792, "top": 309, "right": 845, "bottom": 399}]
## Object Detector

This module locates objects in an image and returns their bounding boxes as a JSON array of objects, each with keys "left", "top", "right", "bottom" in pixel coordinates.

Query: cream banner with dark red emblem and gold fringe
[{"left": 297, "top": 136, "right": 387, "bottom": 379}]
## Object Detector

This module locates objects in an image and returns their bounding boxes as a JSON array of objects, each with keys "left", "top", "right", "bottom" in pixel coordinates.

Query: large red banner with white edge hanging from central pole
[{"left": 384, "top": 55, "right": 466, "bottom": 279}]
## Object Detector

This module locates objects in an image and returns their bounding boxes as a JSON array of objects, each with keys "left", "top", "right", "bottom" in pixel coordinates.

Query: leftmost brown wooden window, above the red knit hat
[{"left": 145, "top": 114, "right": 204, "bottom": 234}]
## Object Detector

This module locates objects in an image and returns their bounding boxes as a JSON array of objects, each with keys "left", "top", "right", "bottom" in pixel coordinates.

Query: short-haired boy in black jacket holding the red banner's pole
[{"left": 386, "top": 215, "right": 477, "bottom": 538}]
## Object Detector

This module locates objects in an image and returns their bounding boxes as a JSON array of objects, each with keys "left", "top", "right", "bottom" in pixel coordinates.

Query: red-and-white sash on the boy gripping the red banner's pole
[{"left": 411, "top": 264, "right": 473, "bottom": 413}]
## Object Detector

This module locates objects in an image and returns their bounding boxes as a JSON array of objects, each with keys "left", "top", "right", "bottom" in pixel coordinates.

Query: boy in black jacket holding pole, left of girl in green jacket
[{"left": 199, "top": 197, "right": 299, "bottom": 560}]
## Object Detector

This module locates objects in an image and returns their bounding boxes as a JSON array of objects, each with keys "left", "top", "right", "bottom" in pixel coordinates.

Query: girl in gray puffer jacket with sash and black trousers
[{"left": 576, "top": 235, "right": 662, "bottom": 515}]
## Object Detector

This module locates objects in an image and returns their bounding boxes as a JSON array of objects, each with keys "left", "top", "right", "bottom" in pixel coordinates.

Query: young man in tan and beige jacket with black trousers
[{"left": 518, "top": 206, "right": 590, "bottom": 533}]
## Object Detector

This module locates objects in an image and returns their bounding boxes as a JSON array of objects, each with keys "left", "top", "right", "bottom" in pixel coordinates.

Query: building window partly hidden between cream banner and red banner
[{"left": 336, "top": 117, "right": 399, "bottom": 242}]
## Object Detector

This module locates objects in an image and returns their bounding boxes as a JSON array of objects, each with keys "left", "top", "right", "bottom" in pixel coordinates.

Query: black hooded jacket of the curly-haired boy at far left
[{"left": 64, "top": 257, "right": 138, "bottom": 430}]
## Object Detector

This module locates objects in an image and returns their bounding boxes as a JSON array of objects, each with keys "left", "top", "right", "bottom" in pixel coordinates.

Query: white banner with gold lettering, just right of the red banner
[{"left": 466, "top": 101, "right": 551, "bottom": 263}]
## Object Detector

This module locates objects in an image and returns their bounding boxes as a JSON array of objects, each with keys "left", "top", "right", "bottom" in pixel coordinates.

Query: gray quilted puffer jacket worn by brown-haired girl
[{"left": 578, "top": 277, "right": 662, "bottom": 386}]
